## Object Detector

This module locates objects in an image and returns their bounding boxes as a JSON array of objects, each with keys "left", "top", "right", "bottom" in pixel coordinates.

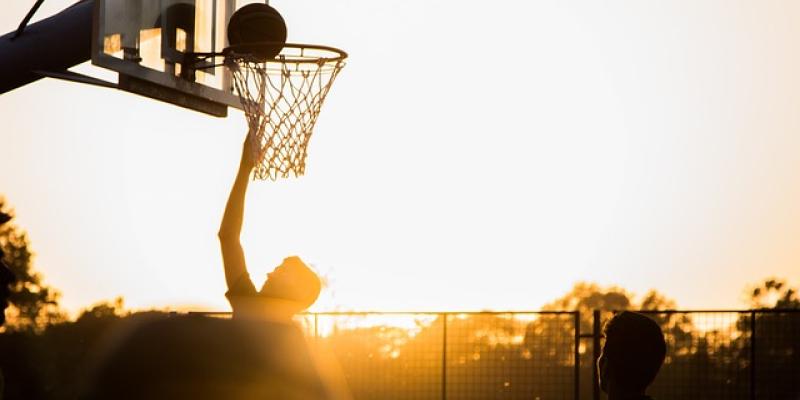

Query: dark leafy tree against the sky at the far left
[{"left": 0, "top": 199, "right": 65, "bottom": 332}]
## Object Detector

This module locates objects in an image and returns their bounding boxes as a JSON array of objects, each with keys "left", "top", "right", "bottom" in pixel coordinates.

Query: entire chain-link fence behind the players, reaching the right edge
[{"left": 189, "top": 310, "right": 800, "bottom": 400}]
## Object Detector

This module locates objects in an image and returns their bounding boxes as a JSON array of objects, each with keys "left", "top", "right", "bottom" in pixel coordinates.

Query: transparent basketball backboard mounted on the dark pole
[{"left": 92, "top": 0, "right": 263, "bottom": 117}]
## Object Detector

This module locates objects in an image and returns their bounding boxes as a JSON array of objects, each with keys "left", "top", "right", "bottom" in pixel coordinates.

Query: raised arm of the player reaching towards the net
[{"left": 218, "top": 135, "right": 253, "bottom": 290}]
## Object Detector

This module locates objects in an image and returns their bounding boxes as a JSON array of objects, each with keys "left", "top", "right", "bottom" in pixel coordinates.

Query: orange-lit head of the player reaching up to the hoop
[{"left": 259, "top": 256, "right": 322, "bottom": 312}]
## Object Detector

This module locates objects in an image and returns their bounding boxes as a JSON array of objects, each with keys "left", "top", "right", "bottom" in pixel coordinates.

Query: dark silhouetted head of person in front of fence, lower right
[{"left": 597, "top": 311, "right": 667, "bottom": 394}]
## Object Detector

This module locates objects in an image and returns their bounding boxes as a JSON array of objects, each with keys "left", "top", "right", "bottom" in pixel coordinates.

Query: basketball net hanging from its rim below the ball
[{"left": 226, "top": 44, "right": 345, "bottom": 181}]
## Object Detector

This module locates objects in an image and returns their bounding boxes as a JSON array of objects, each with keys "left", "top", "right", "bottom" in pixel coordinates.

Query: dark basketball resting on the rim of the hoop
[{"left": 228, "top": 3, "right": 286, "bottom": 61}]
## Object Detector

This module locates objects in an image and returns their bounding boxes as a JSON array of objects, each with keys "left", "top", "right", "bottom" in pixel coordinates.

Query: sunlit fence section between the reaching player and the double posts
[{"left": 303, "top": 312, "right": 580, "bottom": 400}]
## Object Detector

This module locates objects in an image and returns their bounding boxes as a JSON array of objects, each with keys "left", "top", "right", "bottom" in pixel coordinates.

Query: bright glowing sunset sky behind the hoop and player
[{"left": 0, "top": 0, "right": 800, "bottom": 318}]
